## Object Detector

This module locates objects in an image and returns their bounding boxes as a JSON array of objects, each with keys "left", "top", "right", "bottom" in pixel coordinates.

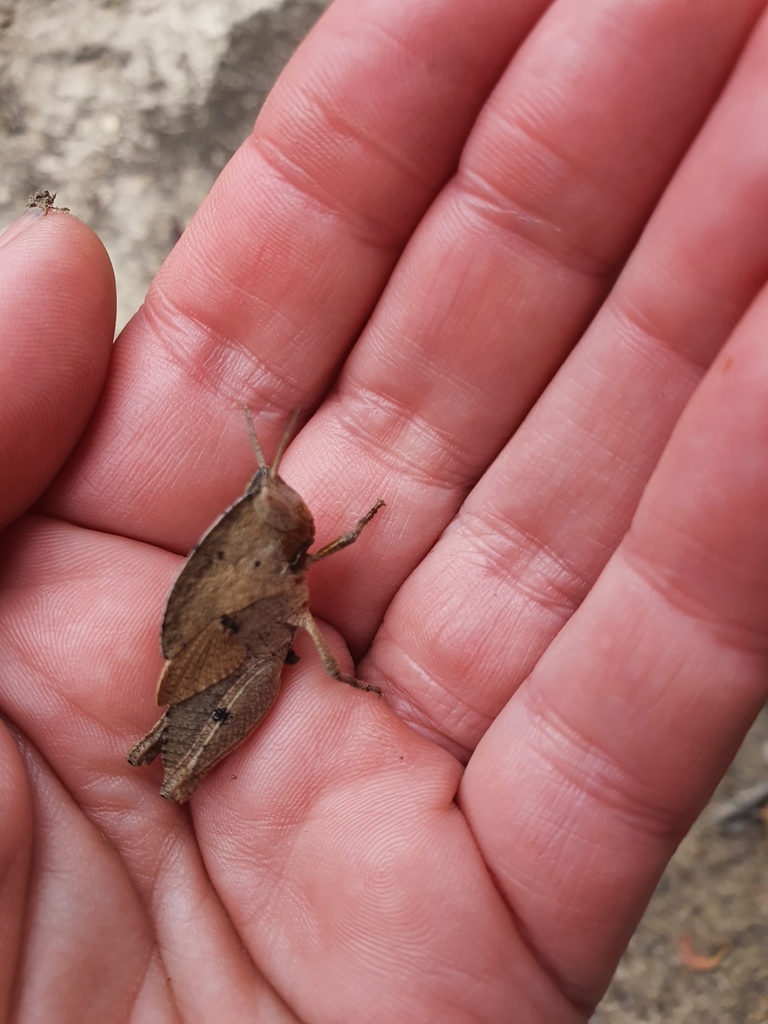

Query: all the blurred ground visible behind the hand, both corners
[{"left": 0, "top": 0, "right": 768, "bottom": 1024}]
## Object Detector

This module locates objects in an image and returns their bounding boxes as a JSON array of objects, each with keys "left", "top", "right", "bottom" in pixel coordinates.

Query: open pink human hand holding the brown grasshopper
[{"left": 0, "top": 0, "right": 768, "bottom": 1024}]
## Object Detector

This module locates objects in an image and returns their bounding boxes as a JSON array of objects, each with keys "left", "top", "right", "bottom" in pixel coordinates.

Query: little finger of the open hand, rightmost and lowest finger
[{"left": 462, "top": 276, "right": 768, "bottom": 1005}]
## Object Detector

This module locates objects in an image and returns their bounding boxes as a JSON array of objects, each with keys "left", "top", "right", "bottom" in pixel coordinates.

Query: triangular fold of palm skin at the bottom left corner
[{"left": 8, "top": 740, "right": 181, "bottom": 1022}]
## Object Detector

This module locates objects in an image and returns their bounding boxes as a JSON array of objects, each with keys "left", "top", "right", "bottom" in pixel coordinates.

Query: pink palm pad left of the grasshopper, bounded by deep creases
[{"left": 0, "top": 516, "right": 293, "bottom": 1024}]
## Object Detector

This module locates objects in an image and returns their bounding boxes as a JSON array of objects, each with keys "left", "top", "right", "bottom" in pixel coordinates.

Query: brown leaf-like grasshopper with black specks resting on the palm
[{"left": 128, "top": 410, "right": 391, "bottom": 803}]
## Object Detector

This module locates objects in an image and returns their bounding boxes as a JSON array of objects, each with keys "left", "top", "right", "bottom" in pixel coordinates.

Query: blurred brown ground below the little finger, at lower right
[{"left": 593, "top": 711, "right": 768, "bottom": 1024}]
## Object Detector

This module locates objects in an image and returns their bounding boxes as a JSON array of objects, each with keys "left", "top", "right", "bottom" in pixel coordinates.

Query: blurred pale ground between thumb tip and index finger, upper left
[{"left": 0, "top": 0, "right": 328, "bottom": 328}]
